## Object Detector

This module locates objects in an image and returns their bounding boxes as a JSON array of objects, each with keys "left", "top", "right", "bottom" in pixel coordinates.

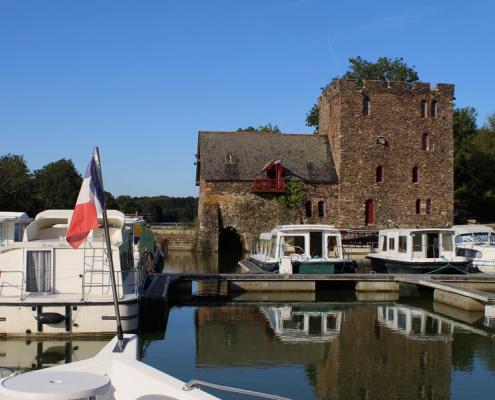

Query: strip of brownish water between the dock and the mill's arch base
[{"left": 165, "top": 251, "right": 243, "bottom": 274}]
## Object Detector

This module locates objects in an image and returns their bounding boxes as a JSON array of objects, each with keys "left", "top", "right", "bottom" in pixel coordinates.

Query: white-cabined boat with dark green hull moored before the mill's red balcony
[{"left": 248, "top": 225, "right": 357, "bottom": 274}]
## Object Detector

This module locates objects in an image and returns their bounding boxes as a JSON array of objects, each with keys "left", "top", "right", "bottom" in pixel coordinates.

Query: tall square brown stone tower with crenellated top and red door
[{"left": 318, "top": 79, "right": 454, "bottom": 228}]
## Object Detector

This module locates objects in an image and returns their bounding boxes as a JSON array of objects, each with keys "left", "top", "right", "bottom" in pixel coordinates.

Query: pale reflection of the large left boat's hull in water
[{"left": 0, "top": 338, "right": 109, "bottom": 370}]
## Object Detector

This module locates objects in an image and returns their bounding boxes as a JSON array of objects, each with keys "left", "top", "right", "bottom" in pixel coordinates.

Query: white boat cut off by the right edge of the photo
[{"left": 452, "top": 224, "right": 495, "bottom": 275}]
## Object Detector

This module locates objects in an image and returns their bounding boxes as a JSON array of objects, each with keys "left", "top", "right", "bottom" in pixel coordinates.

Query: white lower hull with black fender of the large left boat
[{"left": 0, "top": 298, "right": 139, "bottom": 336}]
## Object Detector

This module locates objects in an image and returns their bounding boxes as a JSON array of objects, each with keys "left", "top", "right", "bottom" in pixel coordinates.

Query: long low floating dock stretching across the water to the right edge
[{"left": 145, "top": 272, "right": 495, "bottom": 318}]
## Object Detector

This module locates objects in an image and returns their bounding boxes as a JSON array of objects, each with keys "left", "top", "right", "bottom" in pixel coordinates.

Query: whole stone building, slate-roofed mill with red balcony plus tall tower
[{"left": 196, "top": 79, "right": 454, "bottom": 251}]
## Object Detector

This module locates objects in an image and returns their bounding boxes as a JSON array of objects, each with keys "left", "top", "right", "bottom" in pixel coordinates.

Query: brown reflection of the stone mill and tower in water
[{"left": 196, "top": 303, "right": 453, "bottom": 400}]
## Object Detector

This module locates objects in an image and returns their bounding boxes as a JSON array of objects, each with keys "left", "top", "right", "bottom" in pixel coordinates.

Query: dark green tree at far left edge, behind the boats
[{"left": 0, "top": 154, "right": 36, "bottom": 215}]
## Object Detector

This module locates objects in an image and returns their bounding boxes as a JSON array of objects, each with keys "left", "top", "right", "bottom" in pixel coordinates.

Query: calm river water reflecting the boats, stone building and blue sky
[{"left": 0, "top": 253, "right": 495, "bottom": 400}]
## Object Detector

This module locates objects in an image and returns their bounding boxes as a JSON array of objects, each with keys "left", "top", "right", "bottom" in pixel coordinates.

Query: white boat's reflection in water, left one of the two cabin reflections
[{"left": 260, "top": 306, "right": 342, "bottom": 342}]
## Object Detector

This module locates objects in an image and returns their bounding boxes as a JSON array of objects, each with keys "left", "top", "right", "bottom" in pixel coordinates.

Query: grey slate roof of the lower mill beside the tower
[{"left": 196, "top": 132, "right": 338, "bottom": 183}]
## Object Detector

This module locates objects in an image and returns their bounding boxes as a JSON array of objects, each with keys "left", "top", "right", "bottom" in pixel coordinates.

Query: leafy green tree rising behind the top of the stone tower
[{"left": 306, "top": 57, "right": 419, "bottom": 133}]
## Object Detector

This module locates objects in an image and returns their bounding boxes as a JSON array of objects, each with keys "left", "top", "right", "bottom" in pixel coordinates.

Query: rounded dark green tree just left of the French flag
[{"left": 34, "top": 159, "right": 82, "bottom": 210}]
